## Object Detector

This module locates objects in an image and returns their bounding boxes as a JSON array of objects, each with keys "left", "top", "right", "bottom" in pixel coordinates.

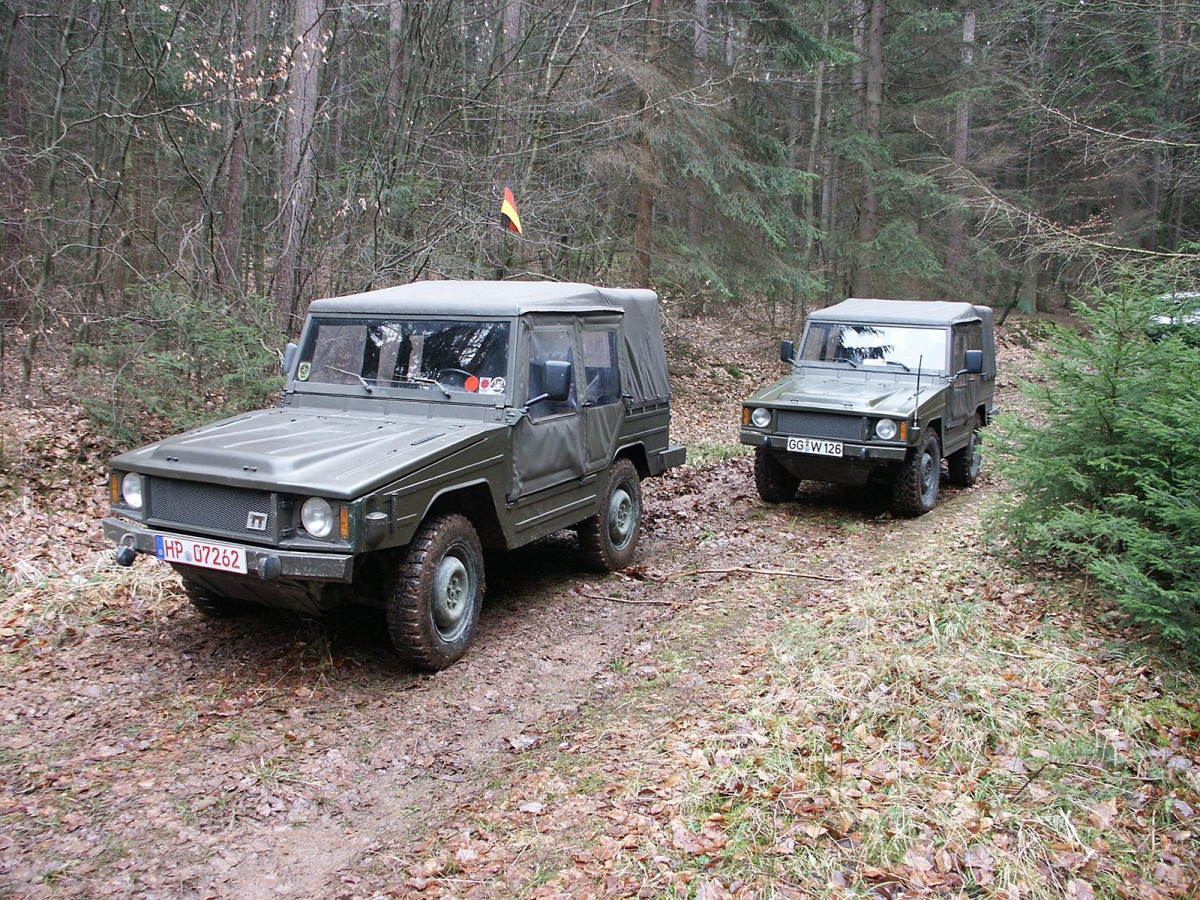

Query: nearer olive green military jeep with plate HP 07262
[{"left": 104, "top": 281, "right": 684, "bottom": 670}]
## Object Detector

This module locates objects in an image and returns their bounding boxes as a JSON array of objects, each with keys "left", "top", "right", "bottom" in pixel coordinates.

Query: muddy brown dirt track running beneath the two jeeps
[{"left": 0, "top": 446, "right": 980, "bottom": 899}]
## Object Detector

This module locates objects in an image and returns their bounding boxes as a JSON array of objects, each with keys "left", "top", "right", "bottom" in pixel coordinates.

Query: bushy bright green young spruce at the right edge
[{"left": 997, "top": 274, "right": 1200, "bottom": 653}]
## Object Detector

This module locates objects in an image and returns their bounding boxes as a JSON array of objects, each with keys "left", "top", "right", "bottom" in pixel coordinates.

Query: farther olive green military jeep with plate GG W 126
[{"left": 740, "top": 300, "right": 996, "bottom": 516}]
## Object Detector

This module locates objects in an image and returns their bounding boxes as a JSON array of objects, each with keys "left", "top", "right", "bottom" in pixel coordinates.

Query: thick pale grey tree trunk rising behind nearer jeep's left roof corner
[{"left": 275, "top": 0, "right": 325, "bottom": 334}]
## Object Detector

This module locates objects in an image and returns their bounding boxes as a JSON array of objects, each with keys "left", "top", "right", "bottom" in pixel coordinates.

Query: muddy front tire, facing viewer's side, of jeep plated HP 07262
[{"left": 386, "top": 514, "right": 484, "bottom": 672}]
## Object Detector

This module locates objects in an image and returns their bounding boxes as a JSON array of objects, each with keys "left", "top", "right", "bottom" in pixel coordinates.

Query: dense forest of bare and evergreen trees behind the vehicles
[{"left": 0, "top": 0, "right": 1200, "bottom": 405}]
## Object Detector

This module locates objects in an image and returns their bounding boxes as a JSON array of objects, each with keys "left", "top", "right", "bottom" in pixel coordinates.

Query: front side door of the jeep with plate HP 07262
[{"left": 509, "top": 324, "right": 586, "bottom": 500}]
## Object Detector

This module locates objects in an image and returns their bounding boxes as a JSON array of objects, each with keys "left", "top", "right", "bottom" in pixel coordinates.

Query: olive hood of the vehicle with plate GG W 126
[{"left": 746, "top": 371, "right": 944, "bottom": 418}]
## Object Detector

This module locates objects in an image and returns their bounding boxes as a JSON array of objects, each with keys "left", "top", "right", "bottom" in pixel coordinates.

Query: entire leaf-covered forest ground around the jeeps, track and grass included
[{"left": 0, "top": 309, "right": 1200, "bottom": 900}]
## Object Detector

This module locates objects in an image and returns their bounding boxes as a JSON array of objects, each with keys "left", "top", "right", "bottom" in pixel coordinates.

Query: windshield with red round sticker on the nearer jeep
[{"left": 295, "top": 318, "right": 509, "bottom": 396}]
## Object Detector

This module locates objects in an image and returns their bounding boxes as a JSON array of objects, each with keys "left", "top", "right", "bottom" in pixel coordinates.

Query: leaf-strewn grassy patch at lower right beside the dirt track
[{"left": 443, "top": 546, "right": 1200, "bottom": 900}]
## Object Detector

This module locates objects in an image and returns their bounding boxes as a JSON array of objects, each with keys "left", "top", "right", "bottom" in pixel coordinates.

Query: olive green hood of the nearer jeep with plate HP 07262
[{"left": 110, "top": 409, "right": 504, "bottom": 499}]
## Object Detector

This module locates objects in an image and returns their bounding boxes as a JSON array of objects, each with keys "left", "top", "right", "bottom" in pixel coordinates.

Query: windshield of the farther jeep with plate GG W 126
[{"left": 799, "top": 322, "right": 948, "bottom": 372}]
